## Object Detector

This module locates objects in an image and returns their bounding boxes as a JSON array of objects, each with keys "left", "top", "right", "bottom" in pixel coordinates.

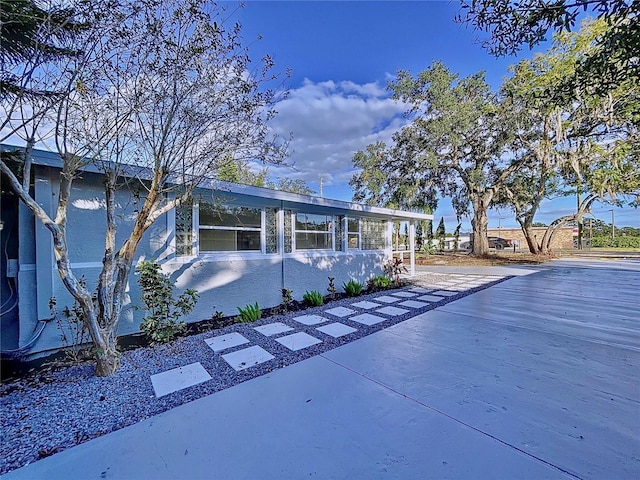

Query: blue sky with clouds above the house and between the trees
[{"left": 234, "top": 0, "right": 640, "bottom": 230}]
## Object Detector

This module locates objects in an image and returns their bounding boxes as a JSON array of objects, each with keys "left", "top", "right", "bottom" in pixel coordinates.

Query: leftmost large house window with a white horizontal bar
[{"left": 199, "top": 204, "right": 263, "bottom": 252}]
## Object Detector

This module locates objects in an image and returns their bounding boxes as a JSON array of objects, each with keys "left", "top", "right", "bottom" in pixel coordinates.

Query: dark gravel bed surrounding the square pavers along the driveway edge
[{"left": 0, "top": 274, "right": 506, "bottom": 474}]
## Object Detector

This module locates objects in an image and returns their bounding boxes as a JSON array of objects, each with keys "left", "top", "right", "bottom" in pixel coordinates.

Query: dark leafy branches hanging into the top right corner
[{"left": 458, "top": 0, "right": 640, "bottom": 95}]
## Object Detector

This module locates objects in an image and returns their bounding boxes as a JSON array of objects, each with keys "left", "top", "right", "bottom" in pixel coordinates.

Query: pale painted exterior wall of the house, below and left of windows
[{"left": 19, "top": 166, "right": 390, "bottom": 356}]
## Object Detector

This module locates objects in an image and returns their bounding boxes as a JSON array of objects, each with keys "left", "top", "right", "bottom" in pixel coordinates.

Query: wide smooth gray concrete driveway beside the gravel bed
[{"left": 4, "top": 259, "right": 640, "bottom": 479}]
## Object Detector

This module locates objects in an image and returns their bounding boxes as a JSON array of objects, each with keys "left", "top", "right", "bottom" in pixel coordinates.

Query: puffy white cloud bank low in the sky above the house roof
[{"left": 269, "top": 80, "right": 407, "bottom": 185}]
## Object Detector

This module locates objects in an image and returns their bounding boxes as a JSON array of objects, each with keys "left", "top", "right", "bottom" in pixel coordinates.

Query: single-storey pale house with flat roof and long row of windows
[{"left": 0, "top": 151, "right": 432, "bottom": 355}]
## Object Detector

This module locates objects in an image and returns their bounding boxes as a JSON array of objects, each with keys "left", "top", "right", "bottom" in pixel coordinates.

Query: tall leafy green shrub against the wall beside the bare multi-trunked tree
[{"left": 136, "top": 260, "right": 198, "bottom": 343}]
